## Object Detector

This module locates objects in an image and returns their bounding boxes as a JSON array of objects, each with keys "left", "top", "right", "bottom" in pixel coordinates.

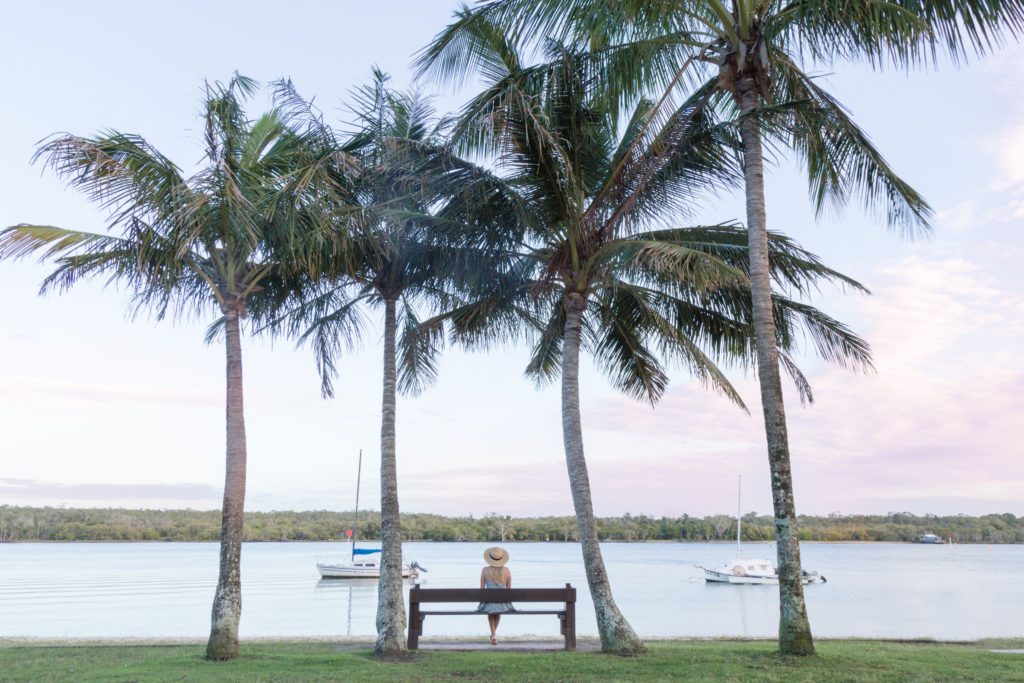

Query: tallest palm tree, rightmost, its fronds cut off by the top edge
[{"left": 424, "top": 0, "right": 1024, "bottom": 654}]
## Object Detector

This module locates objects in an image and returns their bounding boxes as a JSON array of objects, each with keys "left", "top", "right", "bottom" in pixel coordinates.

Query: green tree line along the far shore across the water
[{"left": 0, "top": 505, "right": 1024, "bottom": 544}]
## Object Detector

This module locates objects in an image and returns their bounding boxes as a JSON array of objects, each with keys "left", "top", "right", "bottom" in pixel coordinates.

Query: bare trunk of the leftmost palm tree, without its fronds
[{"left": 206, "top": 310, "right": 246, "bottom": 659}]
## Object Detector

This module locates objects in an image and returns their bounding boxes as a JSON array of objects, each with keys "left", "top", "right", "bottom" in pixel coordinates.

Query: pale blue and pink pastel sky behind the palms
[{"left": 0, "top": 0, "right": 1024, "bottom": 516}]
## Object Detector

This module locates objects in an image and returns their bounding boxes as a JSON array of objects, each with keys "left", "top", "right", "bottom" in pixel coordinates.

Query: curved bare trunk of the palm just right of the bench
[{"left": 562, "top": 293, "right": 645, "bottom": 654}]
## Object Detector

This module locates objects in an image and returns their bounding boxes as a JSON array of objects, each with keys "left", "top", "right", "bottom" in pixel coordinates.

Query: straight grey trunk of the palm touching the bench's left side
[{"left": 374, "top": 298, "right": 406, "bottom": 654}]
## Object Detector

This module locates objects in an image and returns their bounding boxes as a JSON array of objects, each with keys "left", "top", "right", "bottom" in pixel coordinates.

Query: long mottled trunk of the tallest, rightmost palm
[{"left": 737, "top": 77, "right": 814, "bottom": 654}]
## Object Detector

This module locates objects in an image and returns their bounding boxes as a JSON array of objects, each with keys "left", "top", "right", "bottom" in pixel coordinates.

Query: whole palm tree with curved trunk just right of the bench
[{"left": 425, "top": 22, "right": 868, "bottom": 652}]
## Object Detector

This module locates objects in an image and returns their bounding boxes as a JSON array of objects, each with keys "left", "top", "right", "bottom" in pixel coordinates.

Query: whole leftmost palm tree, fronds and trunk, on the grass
[{"left": 0, "top": 75, "right": 348, "bottom": 659}]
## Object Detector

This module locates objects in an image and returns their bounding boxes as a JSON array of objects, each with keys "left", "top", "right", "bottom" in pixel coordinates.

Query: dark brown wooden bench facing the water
[{"left": 409, "top": 584, "right": 575, "bottom": 650}]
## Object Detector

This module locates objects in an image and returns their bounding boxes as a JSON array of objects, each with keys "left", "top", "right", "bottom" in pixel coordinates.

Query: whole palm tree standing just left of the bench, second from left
[{"left": 264, "top": 70, "right": 516, "bottom": 655}]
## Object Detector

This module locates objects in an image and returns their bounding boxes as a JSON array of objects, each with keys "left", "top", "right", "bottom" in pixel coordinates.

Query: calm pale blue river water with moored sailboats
[{"left": 0, "top": 543, "right": 1024, "bottom": 640}]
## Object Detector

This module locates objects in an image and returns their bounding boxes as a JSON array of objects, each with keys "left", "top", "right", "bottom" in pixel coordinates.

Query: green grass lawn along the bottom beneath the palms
[{"left": 0, "top": 641, "right": 1024, "bottom": 683}]
